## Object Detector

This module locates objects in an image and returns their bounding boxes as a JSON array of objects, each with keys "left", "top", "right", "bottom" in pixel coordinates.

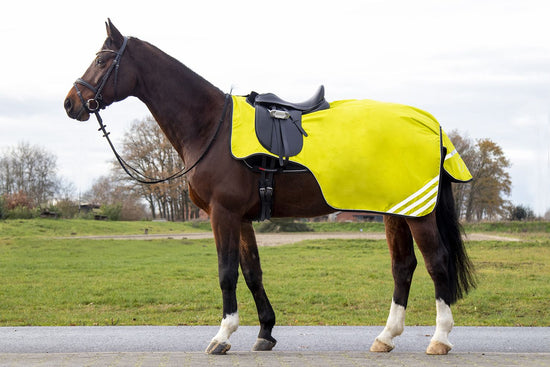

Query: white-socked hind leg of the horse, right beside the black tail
[{"left": 407, "top": 213, "right": 454, "bottom": 354}]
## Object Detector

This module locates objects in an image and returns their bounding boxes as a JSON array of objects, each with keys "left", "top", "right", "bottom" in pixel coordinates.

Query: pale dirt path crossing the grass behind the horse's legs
[{"left": 62, "top": 232, "right": 521, "bottom": 246}]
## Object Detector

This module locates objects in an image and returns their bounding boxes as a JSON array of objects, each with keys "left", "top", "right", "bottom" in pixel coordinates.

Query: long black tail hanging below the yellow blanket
[{"left": 436, "top": 171, "right": 476, "bottom": 304}]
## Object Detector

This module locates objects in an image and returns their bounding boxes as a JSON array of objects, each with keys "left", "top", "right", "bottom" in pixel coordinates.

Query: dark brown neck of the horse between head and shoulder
[{"left": 136, "top": 42, "right": 223, "bottom": 164}]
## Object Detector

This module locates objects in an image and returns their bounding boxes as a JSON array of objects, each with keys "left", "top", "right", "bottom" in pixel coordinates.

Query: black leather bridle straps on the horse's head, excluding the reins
[{"left": 74, "top": 37, "right": 128, "bottom": 116}]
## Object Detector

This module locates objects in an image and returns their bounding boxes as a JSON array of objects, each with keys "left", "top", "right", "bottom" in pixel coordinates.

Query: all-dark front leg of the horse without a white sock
[{"left": 240, "top": 222, "right": 277, "bottom": 351}]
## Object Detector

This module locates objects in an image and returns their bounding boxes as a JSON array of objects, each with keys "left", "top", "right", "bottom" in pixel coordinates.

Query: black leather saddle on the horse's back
[{"left": 246, "top": 86, "right": 330, "bottom": 166}]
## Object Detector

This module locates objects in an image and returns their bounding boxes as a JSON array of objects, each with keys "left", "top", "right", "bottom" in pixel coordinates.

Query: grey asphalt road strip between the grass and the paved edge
[{"left": 0, "top": 326, "right": 550, "bottom": 356}]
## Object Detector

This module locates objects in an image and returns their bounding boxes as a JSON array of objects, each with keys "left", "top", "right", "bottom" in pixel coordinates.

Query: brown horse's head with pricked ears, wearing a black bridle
[{"left": 64, "top": 19, "right": 137, "bottom": 121}]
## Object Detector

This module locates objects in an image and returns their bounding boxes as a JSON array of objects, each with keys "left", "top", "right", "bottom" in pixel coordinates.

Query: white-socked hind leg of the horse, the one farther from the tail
[{"left": 370, "top": 216, "right": 416, "bottom": 352}]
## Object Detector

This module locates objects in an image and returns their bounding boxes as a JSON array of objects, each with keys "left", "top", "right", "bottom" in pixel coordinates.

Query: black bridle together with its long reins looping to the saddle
[{"left": 73, "top": 37, "right": 231, "bottom": 185}]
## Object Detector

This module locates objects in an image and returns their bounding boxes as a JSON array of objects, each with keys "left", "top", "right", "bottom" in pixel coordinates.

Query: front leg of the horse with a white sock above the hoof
[{"left": 206, "top": 208, "right": 241, "bottom": 354}]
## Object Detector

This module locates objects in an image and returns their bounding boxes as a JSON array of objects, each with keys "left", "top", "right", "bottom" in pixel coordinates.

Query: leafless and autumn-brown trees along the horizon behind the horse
[{"left": 0, "top": 121, "right": 550, "bottom": 221}]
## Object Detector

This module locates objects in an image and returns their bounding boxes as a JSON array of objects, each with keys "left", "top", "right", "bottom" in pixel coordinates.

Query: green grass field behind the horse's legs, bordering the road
[{"left": 0, "top": 220, "right": 550, "bottom": 326}]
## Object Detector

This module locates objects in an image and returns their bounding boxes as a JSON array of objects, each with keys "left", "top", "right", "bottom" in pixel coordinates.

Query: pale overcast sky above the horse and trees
[{"left": 0, "top": 0, "right": 550, "bottom": 214}]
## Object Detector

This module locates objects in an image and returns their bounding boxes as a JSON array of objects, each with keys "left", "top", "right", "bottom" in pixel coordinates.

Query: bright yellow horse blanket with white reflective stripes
[{"left": 231, "top": 96, "right": 472, "bottom": 217}]
